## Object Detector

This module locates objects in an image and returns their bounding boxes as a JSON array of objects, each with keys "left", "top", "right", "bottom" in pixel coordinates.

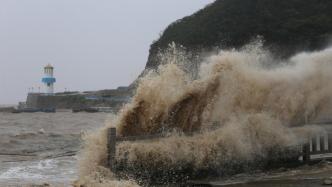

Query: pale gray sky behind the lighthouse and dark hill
[{"left": 0, "top": 0, "right": 213, "bottom": 104}]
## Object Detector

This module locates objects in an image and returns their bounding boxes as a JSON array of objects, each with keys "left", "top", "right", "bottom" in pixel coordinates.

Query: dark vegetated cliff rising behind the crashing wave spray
[{"left": 146, "top": 0, "right": 332, "bottom": 68}]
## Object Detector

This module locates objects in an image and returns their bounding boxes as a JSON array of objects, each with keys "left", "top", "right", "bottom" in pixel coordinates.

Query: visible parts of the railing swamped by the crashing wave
[{"left": 107, "top": 128, "right": 332, "bottom": 169}]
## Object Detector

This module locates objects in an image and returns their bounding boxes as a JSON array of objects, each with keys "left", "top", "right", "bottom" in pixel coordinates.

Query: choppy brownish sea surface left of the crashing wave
[{"left": 0, "top": 111, "right": 112, "bottom": 186}]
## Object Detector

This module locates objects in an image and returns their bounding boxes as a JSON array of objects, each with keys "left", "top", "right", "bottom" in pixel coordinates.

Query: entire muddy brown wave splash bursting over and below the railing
[{"left": 77, "top": 45, "right": 332, "bottom": 186}]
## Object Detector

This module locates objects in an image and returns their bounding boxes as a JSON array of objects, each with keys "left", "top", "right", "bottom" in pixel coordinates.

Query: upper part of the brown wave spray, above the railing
[{"left": 119, "top": 44, "right": 332, "bottom": 136}]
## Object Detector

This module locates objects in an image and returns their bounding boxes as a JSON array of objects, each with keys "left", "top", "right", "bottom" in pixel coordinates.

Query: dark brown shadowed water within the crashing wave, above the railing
[{"left": 120, "top": 74, "right": 219, "bottom": 136}]
